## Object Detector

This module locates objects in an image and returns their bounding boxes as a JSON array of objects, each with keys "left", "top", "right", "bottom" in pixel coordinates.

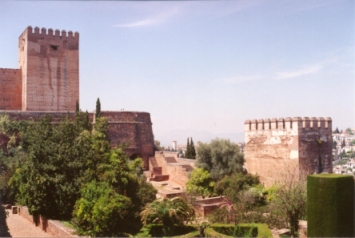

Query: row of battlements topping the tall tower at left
[{"left": 25, "top": 26, "right": 79, "bottom": 41}]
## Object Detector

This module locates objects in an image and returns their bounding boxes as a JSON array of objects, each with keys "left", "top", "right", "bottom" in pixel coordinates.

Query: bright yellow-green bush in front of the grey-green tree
[{"left": 186, "top": 168, "right": 214, "bottom": 197}]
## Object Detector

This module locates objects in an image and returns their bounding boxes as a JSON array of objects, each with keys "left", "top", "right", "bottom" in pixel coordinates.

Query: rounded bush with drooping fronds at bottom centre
[{"left": 141, "top": 197, "right": 195, "bottom": 235}]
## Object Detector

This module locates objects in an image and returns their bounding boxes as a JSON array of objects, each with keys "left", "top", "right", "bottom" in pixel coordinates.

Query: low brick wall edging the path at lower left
[{"left": 18, "top": 206, "right": 79, "bottom": 237}]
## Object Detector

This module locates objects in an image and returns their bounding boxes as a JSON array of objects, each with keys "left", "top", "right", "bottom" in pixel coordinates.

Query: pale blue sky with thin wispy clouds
[{"left": 0, "top": 0, "right": 355, "bottom": 145}]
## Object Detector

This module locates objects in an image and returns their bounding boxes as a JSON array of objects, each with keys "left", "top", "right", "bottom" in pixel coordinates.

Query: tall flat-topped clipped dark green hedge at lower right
[{"left": 307, "top": 174, "right": 354, "bottom": 237}]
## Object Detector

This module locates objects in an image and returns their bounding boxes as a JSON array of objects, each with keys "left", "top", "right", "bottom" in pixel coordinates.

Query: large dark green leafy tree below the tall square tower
[{"left": 9, "top": 116, "right": 87, "bottom": 219}]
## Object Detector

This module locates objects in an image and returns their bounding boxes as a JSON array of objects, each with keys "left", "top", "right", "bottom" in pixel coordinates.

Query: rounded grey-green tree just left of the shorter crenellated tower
[{"left": 196, "top": 138, "right": 244, "bottom": 181}]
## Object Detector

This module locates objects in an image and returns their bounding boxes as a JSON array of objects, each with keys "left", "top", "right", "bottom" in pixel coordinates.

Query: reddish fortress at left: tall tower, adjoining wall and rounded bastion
[{"left": 0, "top": 26, "right": 155, "bottom": 170}]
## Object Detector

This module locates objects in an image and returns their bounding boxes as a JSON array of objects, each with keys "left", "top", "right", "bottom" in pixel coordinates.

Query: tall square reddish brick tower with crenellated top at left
[{"left": 19, "top": 26, "right": 79, "bottom": 111}]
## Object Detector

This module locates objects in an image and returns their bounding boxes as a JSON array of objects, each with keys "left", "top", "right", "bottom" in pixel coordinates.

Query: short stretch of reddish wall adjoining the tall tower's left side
[{"left": 0, "top": 68, "right": 22, "bottom": 110}]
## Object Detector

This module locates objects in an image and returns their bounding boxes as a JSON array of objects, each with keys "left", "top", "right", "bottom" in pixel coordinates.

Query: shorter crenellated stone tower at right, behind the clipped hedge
[{"left": 244, "top": 117, "right": 332, "bottom": 186}]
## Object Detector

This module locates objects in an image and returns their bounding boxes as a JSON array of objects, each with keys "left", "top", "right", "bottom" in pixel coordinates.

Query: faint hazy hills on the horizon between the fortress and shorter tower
[{"left": 154, "top": 130, "right": 244, "bottom": 146}]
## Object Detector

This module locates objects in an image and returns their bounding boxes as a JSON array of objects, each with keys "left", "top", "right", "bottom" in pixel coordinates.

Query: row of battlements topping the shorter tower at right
[{"left": 244, "top": 117, "right": 332, "bottom": 131}]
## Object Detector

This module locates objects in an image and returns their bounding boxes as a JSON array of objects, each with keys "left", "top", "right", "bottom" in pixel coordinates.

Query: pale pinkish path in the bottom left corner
[{"left": 6, "top": 210, "right": 53, "bottom": 237}]
